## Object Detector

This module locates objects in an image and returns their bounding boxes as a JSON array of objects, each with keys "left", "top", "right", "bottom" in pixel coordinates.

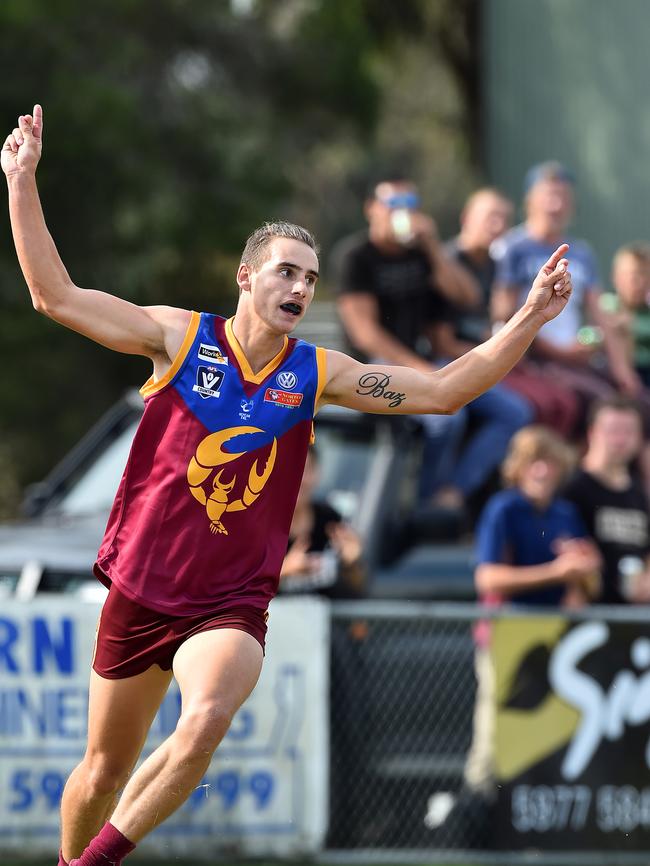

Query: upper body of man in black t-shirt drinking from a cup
[{"left": 332, "top": 180, "right": 480, "bottom": 371}]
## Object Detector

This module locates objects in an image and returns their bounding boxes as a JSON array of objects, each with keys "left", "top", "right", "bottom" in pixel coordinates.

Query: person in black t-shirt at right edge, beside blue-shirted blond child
[{"left": 564, "top": 397, "right": 650, "bottom": 604}]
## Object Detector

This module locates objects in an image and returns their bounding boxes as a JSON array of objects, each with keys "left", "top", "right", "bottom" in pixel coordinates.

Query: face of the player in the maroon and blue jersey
[{"left": 237, "top": 238, "right": 318, "bottom": 334}]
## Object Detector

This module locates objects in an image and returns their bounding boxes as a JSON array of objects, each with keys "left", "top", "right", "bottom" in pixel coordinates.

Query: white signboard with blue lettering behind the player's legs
[{"left": 0, "top": 597, "right": 329, "bottom": 859}]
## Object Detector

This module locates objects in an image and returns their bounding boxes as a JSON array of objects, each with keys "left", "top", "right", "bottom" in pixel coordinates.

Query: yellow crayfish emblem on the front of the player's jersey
[{"left": 187, "top": 426, "right": 278, "bottom": 535}]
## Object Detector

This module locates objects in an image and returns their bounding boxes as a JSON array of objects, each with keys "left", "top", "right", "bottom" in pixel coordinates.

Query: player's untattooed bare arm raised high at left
[{"left": 2, "top": 105, "right": 190, "bottom": 375}]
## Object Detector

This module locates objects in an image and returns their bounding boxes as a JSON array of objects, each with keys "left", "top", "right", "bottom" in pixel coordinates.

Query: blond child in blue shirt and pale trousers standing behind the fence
[{"left": 430, "top": 426, "right": 600, "bottom": 834}]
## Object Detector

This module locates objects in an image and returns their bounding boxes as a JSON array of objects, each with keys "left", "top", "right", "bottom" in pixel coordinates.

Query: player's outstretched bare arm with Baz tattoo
[{"left": 322, "top": 244, "right": 571, "bottom": 414}]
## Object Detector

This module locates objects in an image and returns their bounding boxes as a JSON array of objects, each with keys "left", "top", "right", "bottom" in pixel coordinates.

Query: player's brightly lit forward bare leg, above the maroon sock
[{"left": 110, "top": 628, "right": 263, "bottom": 842}]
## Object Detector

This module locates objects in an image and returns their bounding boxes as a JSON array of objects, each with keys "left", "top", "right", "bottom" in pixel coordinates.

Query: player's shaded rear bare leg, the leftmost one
[{"left": 61, "top": 665, "right": 172, "bottom": 863}]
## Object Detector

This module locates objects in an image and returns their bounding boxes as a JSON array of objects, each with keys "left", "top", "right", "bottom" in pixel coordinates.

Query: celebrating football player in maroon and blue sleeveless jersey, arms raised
[{"left": 2, "top": 105, "right": 571, "bottom": 866}]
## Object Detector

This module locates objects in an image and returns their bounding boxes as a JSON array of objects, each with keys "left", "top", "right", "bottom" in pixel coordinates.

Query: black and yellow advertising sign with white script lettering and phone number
[{"left": 492, "top": 617, "right": 650, "bottom": 851}]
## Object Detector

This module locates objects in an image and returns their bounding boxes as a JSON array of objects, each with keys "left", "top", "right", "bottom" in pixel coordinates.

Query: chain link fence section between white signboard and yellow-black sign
[{"left": 328, "top": 608, "right": 476, "bottom": 849}]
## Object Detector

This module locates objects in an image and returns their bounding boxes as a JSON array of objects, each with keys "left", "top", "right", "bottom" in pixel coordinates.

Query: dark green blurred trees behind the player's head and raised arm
[{"left": 0, "top": 0, "right": 474, "bottom": 510}]
